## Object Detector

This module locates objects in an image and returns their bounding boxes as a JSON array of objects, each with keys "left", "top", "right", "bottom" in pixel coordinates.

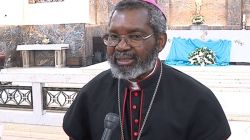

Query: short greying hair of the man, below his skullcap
[{"left": 108, "top": 0, "right": 167, "bottom": 35}]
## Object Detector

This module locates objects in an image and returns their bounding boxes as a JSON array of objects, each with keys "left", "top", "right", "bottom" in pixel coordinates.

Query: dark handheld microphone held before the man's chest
[{"left": 101, "top": 113, "right": 119, "bottom": 140}]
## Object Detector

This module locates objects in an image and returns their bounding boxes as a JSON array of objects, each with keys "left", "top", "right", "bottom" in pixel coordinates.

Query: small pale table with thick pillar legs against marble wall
[{"left": 16, "top": 44, "right": 69, "bottom": 68}]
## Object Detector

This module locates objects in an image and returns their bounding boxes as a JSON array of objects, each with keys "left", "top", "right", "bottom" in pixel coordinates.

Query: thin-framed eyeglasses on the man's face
[{"left": 103, "top": 33, "right": 154, "bottom": 47}]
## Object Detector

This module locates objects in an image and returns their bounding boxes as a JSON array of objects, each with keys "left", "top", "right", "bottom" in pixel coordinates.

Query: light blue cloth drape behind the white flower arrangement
[{"left": 165, "top": 37, "right": 232, "bottom": 66}]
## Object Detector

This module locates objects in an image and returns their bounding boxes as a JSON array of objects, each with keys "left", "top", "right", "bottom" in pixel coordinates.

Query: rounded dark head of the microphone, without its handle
[{"left": 104, "top": 113, "right": 120, "bottom": 130}]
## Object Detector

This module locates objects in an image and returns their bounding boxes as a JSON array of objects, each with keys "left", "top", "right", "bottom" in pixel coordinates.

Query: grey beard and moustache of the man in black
[{"left": 108, "top": 48, "right": 158, "bottom": 80}]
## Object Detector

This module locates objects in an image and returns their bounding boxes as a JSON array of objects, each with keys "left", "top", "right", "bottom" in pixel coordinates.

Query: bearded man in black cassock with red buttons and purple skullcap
[{"left": 63, "top": 0, "right": 231, "bottom": 140}]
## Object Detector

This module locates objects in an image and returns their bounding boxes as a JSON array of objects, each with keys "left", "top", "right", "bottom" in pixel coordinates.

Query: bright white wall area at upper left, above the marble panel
[{"left": 0, "top": 0, "right": 89, "bottom": 25}]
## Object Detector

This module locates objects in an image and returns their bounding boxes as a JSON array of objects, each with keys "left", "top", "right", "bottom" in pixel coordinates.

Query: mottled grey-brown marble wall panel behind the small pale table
[{"left": 0, "top": 24, "right": 87, "bottom": 66}]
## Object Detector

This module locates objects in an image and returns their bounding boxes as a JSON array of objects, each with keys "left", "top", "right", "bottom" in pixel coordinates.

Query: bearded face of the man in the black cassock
[{"left": 107, "top": 8, "right": 158, "bottom": 79}]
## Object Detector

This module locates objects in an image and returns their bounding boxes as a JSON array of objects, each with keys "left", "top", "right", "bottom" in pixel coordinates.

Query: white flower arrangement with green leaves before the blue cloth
[{"left": 188, "top": 47, "right": 215, "bottom": 66}]
